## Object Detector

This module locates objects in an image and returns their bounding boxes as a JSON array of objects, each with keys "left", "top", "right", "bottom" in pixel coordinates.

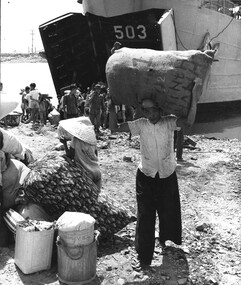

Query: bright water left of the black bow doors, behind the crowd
[{"left": 1, "top": 62, "right": 57, "bottom": 106}]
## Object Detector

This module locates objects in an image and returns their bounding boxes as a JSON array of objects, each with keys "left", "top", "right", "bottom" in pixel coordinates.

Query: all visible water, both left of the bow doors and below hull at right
[{"left": 1, "top": 63, "right": 241, "bottom": 141}]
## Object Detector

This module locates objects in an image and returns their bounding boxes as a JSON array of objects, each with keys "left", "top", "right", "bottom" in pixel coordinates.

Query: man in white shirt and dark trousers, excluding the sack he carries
[{"left": 110, "top": 99, "right": 182, "bottom": 267}]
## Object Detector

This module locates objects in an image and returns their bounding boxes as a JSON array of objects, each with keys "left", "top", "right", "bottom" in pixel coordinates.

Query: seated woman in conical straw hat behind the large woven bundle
[{"left": 58, "top": 117, "right": 101, "bottom": 189}]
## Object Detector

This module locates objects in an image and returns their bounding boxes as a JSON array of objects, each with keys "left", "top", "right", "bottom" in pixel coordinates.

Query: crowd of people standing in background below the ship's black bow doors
[{"left": 17, "top": 79, "right": 184, "bottom": 161}]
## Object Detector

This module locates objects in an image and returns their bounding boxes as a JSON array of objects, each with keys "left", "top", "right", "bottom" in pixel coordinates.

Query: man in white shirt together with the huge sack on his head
[{"left": 106, "top": 45, "right": 216, "bottom": 268}]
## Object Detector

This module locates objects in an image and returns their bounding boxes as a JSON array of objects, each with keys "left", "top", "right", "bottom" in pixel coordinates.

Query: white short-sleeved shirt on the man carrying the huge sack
[{"left": 128, "top": 115, "right": 177, "bottom": 178}]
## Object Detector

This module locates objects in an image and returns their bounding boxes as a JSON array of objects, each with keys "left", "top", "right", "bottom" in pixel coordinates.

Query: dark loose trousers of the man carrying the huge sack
[{"left": 135, "top": 169, "right": 182, "bottom": 264}]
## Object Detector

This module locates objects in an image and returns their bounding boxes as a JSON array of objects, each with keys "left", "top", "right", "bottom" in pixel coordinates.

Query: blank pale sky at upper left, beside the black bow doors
[{"left": 0, "top": 0, "right": 82, "bottom": 53}]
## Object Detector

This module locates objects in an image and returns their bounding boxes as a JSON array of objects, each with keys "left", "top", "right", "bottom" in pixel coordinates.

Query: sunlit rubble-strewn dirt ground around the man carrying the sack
[{"left": 0, "top": 120, "right": 241, "bottom": 285}]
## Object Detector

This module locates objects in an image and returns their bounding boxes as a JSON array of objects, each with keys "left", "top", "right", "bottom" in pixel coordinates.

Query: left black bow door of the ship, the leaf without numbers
[{"left": 39, "top": 13, "right": 98, "bottom": 94}]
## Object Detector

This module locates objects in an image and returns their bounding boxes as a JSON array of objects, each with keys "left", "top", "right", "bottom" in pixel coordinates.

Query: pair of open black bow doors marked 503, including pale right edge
[{"left": 39, "top": 9, "right": 173, "bottom": 94}]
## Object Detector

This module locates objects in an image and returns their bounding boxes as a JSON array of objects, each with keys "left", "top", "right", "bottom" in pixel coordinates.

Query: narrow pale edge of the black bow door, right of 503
[{"left": 158, "top": 9, "right": 177, "bottom": 50}]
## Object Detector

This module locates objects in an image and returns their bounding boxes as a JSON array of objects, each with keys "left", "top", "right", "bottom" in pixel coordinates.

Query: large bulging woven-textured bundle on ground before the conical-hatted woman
[{"left": 24, "top": 152, "right": 135, "bottom": 238}]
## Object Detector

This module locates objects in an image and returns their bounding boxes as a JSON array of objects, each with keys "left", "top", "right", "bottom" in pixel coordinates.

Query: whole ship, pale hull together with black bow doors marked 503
[{"left": 40, "top": 0, "right": 241, "bottom": 104}]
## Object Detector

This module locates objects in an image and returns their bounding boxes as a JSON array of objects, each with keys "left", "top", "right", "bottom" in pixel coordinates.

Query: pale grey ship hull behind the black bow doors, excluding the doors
[{"left": 83, "top": 0, "right": 241, "bottom": 103}]
